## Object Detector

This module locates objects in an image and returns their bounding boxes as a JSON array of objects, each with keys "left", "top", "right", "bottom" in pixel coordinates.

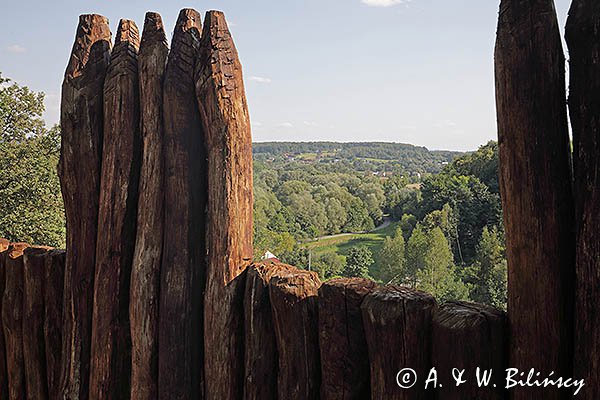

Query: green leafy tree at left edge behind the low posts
[{"left": 0, "top": 75, "right": 65, "bottom": 246}]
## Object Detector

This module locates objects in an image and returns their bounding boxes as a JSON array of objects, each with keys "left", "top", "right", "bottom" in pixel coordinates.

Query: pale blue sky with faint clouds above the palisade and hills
[{"left": 0, "top": 0, "right": 569, "bottom": 150}]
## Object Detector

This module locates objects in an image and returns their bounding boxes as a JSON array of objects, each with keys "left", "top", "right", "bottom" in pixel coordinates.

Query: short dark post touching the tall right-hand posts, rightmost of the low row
[{"left": 432, "top": 301, "right": 508, "bottom": 400}]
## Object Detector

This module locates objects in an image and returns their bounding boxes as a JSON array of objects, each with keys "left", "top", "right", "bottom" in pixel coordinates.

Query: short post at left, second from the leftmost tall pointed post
[{"left": 23, "top": 247, "right": 51, "bottom": 400}]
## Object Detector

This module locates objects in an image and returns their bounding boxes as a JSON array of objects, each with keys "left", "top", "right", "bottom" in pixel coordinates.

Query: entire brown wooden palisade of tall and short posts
[{"left": 0, "top": 0, "right": 600, "bottom": 400}]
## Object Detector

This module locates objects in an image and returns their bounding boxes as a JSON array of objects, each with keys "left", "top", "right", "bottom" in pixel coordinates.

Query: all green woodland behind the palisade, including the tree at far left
[{"left": 0, "top": 75, "right": 506, "bottom": 307}]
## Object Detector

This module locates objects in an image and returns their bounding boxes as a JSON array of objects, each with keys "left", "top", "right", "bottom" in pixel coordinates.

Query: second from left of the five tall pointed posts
[{"left": 90, "top": 20, "right": 141, "bottom": 400}]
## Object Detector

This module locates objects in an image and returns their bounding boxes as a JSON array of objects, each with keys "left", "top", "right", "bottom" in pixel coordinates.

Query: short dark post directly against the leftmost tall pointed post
[{"left": 44, "top": 250, "right": 66, "bottom": 400}]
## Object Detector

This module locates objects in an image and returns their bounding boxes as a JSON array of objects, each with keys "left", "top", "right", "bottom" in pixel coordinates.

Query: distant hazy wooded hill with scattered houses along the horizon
[{"left": 253, "top": 142, "right": 464, "bottom": 174}]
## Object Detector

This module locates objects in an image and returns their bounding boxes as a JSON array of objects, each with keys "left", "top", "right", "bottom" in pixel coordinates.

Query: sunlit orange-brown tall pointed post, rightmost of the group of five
[{"left": 196, "top": 11, "right": 253, "bottom": 399}]
